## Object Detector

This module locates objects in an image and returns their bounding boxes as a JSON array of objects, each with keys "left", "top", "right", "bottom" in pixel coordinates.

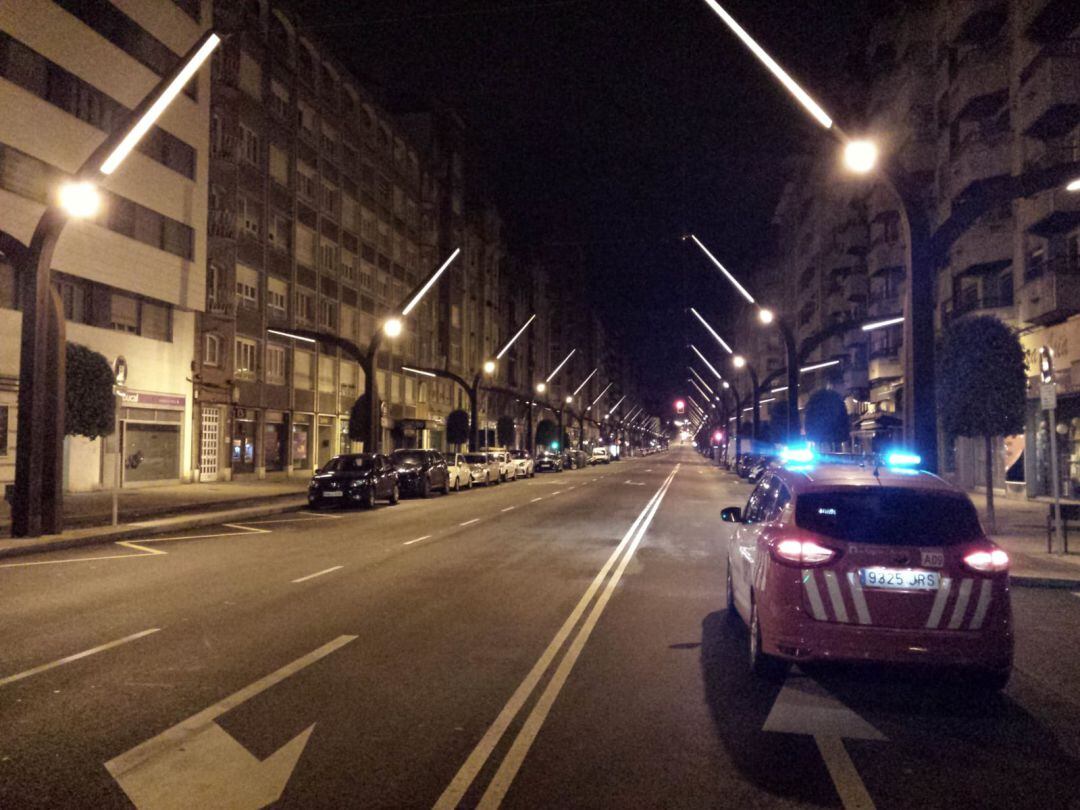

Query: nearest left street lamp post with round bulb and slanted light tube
[{"left": 11, "top": 31, "right": 221, "bottom": 537}]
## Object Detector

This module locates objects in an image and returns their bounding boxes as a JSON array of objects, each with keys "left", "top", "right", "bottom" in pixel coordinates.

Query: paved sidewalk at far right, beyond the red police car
[{"left": 970, "top": 492, "right": 1080, "bottom": 590}]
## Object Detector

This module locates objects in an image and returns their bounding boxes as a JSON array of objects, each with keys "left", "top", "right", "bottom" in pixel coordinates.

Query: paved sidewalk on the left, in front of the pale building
[{"left": 0, "top": 478, "right": 308, "bottom": 557}]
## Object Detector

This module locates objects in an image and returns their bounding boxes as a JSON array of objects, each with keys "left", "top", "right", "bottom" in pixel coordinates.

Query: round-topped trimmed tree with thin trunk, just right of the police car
[{"left": 937, "top": 315, "right": 1027, "bottom": 531}]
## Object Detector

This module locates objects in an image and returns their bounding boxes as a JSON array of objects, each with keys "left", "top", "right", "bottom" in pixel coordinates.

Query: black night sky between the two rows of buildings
[{"left": 300, "top": 0, "right": 882, "bottom": 407}]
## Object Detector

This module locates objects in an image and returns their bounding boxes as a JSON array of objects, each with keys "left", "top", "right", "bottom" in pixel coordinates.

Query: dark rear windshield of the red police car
[{"left": 795, "top": 487, "right": 982, "bottom": 545}]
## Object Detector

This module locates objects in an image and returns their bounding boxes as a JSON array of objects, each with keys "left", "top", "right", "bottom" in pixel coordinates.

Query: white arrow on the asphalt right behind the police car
[{"left": 762, "top": 674, "right": 888, "bottom": 810}]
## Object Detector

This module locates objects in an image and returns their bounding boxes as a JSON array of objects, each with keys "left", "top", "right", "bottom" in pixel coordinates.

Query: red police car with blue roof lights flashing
[{"left": 721, "top": 449, "right": 1013, "bottom": 689}]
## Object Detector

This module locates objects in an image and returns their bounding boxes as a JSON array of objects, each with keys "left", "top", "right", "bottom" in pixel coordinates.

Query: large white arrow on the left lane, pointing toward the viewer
[{"left": 105, "top": 636, "right": 356, "bottom": 810}]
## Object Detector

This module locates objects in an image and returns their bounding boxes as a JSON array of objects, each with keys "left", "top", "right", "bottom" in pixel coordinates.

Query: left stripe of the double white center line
[{"left": 434, "top": 467, "right": 678, "bottom": 810}]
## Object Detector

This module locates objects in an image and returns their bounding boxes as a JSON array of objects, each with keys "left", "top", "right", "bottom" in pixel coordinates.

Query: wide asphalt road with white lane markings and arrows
[{"left": 6, "top": 449, "right": 1080, "bottom": 808}]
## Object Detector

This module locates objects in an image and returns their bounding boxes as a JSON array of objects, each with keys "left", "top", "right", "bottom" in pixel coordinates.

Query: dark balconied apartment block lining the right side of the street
[{"left": 743, "top": 0, "right": 1080, "bottom": 495}]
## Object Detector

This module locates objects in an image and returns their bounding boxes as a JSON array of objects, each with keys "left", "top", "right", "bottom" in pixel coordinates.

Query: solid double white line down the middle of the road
[{"left": 434, "top": 464, "right": 679, "bottom": 810}]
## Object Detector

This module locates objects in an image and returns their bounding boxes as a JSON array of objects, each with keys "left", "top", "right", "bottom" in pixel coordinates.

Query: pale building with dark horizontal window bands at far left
[{"left": 0, "top": 0, "right": 212, "bottom": 490}]
